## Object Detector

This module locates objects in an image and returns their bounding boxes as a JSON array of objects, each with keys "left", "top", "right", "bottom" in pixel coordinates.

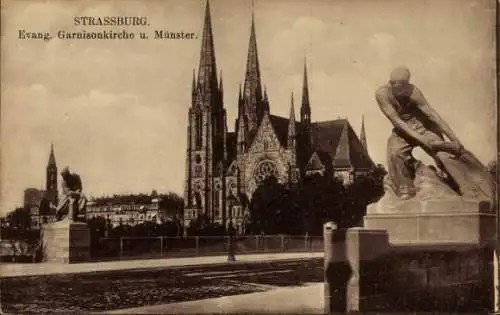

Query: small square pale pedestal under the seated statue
[{"left": 43, "top": 220, "right": 90, "bottom": 264}]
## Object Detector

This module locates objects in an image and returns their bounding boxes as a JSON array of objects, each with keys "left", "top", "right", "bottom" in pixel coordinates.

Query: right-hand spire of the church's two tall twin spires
[{"left": 243, "top": 8, "right": 264, "bottom": 129}]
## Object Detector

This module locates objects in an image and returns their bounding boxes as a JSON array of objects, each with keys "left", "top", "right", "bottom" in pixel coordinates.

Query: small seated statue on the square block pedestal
[{"left": 56, "top": 167, "right": 87, "bottom": 221}]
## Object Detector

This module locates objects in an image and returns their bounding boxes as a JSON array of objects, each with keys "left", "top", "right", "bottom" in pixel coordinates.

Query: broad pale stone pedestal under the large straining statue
[{"left": 364, "top": 198, "right": 496, "bottom": 246}]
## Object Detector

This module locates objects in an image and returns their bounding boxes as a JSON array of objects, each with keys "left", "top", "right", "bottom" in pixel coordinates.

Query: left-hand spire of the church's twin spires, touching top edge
[{"left": 198, "top": 0, "right": 217, "bottom": 97}]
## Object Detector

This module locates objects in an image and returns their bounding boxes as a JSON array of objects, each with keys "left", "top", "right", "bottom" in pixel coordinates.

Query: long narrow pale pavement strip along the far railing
[{"left": 0, "top": 252, "right": 324, "bottom": 278}]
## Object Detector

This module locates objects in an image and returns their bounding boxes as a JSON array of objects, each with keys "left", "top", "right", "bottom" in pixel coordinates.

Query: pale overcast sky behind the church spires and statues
[{"left": 0, "top": 0, "right": 496, "bottom": 214}]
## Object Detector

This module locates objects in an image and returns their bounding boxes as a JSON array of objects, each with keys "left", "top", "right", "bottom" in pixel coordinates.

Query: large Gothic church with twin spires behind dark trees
[{"left": 184, "top": 1, "right": 375, "bottom": 235}]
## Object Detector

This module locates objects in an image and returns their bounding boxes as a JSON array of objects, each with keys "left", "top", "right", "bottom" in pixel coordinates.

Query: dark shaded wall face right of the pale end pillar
[{"left": 359, "top": 246, "right": 493, "bottom": 312}]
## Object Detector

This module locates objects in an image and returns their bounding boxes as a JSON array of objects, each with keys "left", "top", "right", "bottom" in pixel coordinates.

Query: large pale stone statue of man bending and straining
[{"left": 375, "top": 67, "right": 492, "bottom": 200}]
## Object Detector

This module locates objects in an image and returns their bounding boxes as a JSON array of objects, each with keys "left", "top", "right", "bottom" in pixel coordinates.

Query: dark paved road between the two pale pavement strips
[{"left": 0, "top": 258, "right": 323, "bottom": 313}]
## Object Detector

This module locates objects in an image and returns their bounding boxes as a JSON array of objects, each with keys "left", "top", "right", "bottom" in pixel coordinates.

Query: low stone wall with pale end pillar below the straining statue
[{"left": 325, "top": 228, "right": 494, "bottom": 314}]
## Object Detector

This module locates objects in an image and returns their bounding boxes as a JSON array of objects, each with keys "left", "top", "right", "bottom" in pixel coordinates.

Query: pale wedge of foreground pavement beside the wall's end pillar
[{"left": 105, "top": 283, "right": 324, "bottom": 314}]
